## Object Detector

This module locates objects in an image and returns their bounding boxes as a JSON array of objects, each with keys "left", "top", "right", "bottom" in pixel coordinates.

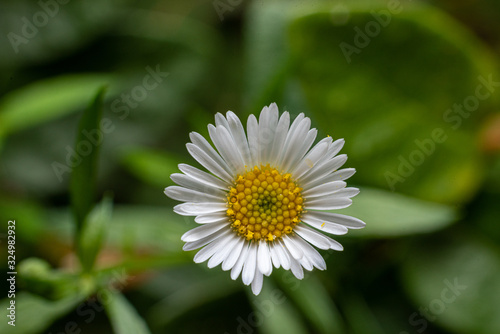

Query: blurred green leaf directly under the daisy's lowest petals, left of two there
[{"left": 243, "top": 280, "right": 309, "bottom": 334}]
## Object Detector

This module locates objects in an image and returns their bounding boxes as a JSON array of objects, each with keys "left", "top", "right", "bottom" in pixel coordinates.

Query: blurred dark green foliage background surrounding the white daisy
[{"left": 0, "top": 0, "right": 500, "bottom": 334}]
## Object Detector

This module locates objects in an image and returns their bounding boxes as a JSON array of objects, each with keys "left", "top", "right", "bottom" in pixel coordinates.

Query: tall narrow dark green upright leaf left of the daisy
[{"left": 70, "top": 88, "right": 105, "bottom": 232}]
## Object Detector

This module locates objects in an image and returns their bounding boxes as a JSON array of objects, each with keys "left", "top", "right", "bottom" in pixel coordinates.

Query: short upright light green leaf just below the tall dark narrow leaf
[{"left": 78, "top": 197, "right": 113, "bottom": 271}]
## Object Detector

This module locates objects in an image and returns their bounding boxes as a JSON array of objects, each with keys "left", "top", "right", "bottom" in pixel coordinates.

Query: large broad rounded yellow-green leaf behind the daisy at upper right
[{"left": 289, "top": 3, "right": 497, "bottom": 203}]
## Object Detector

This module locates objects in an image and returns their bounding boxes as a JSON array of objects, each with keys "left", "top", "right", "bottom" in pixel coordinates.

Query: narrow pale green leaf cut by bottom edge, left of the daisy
[{"left": 104, "top": 292, "right": 150, "bottom": 334}]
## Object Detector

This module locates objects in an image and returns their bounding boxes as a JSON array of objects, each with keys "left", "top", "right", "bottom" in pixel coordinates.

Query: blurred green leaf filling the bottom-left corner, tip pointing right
[{"left": 0, "top": 292, "right": 86, "bottom": 334}]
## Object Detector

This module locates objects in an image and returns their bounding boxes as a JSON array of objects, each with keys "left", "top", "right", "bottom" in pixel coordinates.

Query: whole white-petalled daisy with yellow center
[{"left": 165, "top": 103, "right": 365, "bottom": 295}]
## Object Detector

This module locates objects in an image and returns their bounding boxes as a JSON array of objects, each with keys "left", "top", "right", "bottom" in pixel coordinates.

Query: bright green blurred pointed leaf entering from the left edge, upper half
[{"left": 0, "top": 74, "right": 110, "bottom": 138}]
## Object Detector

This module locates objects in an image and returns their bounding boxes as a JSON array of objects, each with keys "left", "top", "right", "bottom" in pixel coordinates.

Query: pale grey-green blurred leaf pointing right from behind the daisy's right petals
[{"left": 335, "top": 188, "right": 458, "bottom": 237}]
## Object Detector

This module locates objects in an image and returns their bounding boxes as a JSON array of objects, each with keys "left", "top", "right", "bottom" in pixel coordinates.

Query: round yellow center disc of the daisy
[{"left": 226, "top": 165, "right": 304, "bottom": 241}]
